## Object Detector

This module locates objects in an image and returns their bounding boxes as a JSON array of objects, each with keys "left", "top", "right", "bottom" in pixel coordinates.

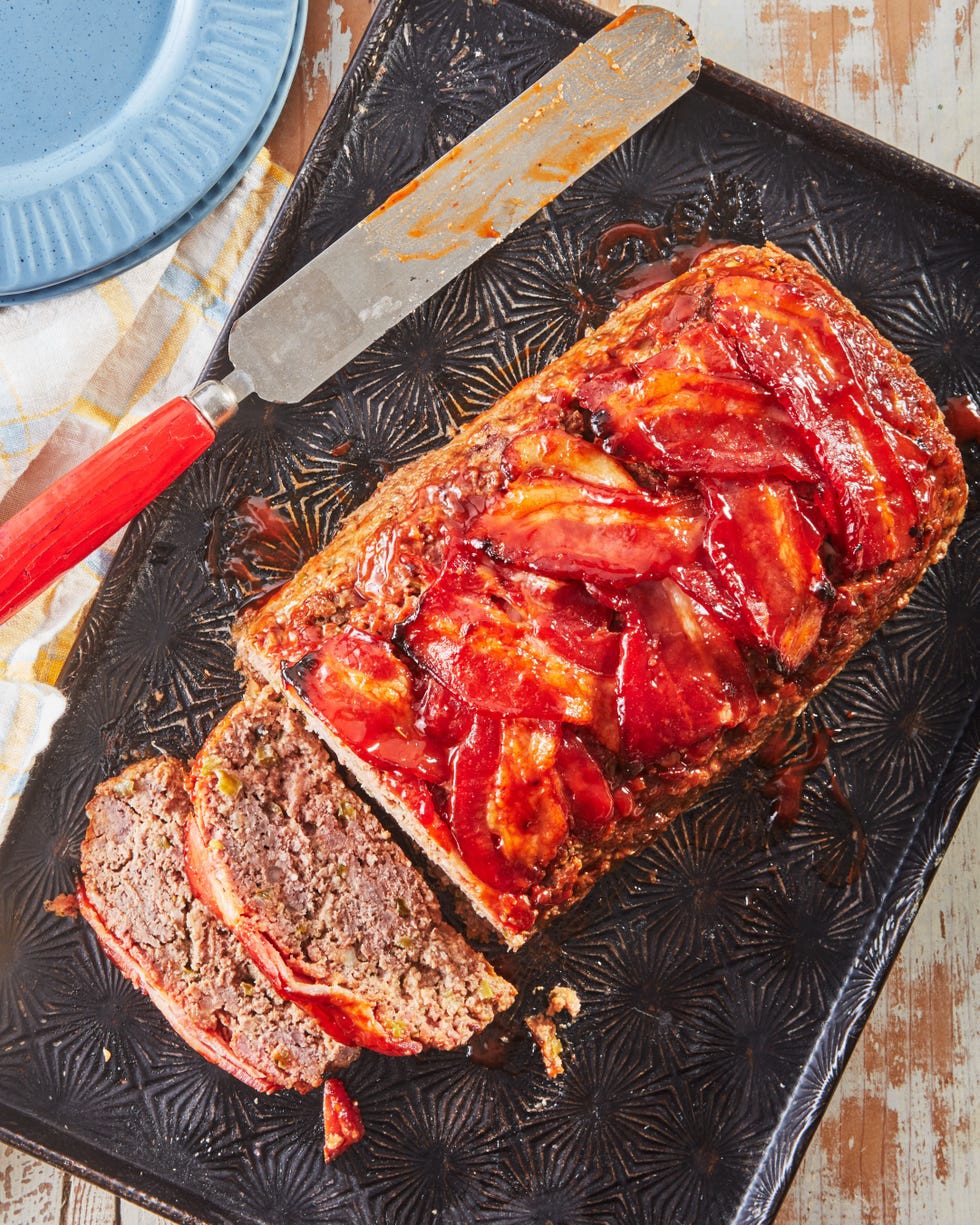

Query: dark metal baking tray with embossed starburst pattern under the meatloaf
[{"left": 0, "top": 0, "right": 980, "bottom": 1225}]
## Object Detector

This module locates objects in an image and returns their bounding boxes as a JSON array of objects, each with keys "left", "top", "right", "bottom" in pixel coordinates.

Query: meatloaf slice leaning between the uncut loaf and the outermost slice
[{"left": 189, "top": 690, "right": 515, "bottom": 1055}]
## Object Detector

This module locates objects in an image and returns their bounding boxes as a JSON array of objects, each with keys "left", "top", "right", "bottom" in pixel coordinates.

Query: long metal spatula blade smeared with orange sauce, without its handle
[{"left": 228, "top": 7, "right": 701, "bottom": 403}]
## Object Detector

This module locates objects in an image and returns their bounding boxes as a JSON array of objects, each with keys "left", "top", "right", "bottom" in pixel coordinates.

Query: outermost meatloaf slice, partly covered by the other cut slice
[{"left": 77, "top": 757, "right": 358, "bottom": 1093}]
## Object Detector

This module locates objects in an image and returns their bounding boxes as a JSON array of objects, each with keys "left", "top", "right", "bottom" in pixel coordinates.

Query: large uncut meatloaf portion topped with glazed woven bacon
[{"left": 239, "top": 245, "right": 965, "bottom": 947}]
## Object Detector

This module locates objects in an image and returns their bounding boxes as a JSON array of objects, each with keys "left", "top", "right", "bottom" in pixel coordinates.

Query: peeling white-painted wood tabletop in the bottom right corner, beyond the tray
[{"left": 778, "top": 800, "right": 980, "bottom": 1225}]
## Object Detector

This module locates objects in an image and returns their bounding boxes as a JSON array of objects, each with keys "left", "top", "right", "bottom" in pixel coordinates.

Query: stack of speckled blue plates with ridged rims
[{"left": 0, "top": 0, "right": 306, "bottom": 305}]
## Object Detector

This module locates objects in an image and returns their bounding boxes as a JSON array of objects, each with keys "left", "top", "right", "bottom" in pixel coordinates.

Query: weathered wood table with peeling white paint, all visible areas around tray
[{"left": 0, "top": 0, "right": 980, "bottom": 1225}]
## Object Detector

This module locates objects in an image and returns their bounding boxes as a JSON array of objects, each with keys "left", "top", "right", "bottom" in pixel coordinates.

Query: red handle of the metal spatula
[{"left": 0, "top": 396, "right": 214, "bottom": 621}]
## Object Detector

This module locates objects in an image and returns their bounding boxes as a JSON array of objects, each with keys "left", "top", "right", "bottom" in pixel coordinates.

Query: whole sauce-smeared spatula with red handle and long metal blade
[{"left": 0, "top": 7, "right": 701, "bottom": 621}]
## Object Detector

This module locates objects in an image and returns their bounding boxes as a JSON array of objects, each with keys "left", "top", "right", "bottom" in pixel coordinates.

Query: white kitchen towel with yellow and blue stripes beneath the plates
[{"left": 0, "top": 149, "right": 290, "bottom": 839}]
